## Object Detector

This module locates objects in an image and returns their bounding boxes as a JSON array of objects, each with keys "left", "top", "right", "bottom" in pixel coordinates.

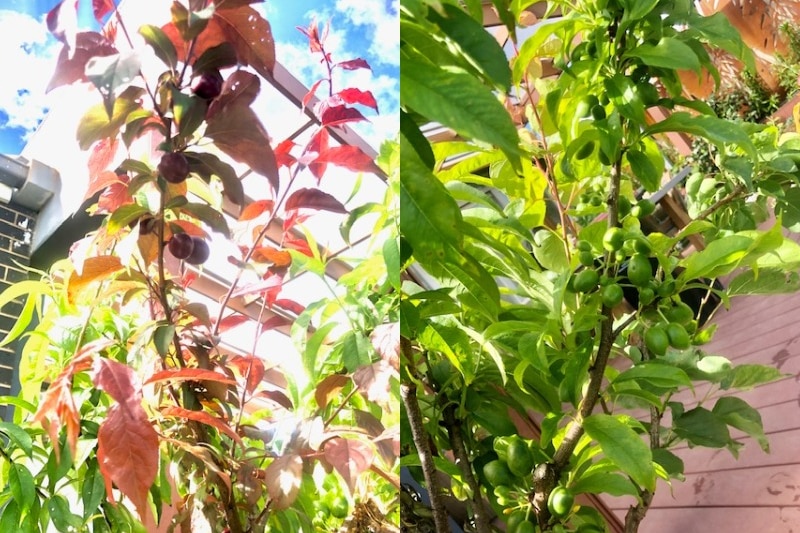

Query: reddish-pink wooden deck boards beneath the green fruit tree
[{"left": 604, "top": 262, "right": 800, "bottom": 533}]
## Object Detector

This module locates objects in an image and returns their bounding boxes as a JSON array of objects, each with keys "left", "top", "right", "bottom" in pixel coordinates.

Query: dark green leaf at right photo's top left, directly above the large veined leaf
[{"left": 428, "top": 4, "right": 511, "bottom": 91}]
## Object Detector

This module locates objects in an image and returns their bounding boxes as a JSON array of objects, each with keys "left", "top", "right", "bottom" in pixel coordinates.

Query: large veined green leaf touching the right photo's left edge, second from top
[{"left": 400, "top": 52, "right": 521, "bottom": 162}]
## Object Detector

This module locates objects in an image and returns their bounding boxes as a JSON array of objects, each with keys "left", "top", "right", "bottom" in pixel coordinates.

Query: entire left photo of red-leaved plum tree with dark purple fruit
[{"left": 0, "top": 0, "right": 405, "bottom": 533}]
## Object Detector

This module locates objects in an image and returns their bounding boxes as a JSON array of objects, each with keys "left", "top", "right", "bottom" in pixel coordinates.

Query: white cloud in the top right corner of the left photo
[{"left": 336, "top": 0, "right": 400, "bottom": 65}]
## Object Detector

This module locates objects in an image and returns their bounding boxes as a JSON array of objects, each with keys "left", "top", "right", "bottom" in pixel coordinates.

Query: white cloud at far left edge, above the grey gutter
[{"left": 0, "top": 10, "right": 60, "bottom": 131}]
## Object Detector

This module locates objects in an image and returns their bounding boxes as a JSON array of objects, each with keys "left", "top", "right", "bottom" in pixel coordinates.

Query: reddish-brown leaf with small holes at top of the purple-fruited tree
[{"left": 212, "top": 3, "right": 275, "bottom": 78}]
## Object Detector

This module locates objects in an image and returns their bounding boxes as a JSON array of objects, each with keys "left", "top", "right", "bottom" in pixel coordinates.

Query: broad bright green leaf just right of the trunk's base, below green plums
[{"left": 583, "top": 413, "right": 656, "bottom": 491}]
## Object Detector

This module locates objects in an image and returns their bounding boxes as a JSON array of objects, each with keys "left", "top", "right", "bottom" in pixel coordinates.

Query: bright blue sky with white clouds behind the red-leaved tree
[{"left": 0, "top": 0, "right": 400, "bottom": 154}]
